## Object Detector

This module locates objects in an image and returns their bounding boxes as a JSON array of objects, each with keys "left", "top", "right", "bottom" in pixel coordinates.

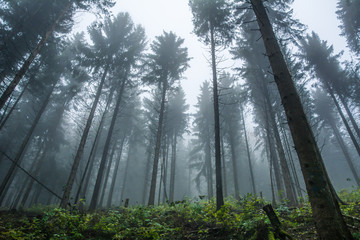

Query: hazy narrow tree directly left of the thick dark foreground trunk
[{"left": 233, "top": 29, "right": 296, "bottom": 204}]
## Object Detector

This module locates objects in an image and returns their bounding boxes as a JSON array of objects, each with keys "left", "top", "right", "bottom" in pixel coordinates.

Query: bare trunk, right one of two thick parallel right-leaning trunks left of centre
[{"left": 89, "top": 76, "right": 127, "bottom": 211}]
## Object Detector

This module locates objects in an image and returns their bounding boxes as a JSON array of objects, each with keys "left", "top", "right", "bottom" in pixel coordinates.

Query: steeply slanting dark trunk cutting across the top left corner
[{"left": 0, "top": 1, "right": 72, "bottom": 110}]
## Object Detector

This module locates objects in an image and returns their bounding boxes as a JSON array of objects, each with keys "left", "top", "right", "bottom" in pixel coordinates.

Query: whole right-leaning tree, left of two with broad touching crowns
[{"left": 60, "top": 13, "right": 143, "bottom": 208}]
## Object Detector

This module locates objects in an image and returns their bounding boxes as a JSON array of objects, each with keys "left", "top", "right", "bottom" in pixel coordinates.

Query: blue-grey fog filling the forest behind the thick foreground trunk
[{"left": 0, "top": 0, "right": 360, "bottom": 210}]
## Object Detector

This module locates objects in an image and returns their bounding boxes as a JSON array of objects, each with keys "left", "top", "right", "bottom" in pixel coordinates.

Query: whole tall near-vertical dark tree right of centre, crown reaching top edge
[{"left": 189, "top": 0, "right": 233, "bottom": 210}]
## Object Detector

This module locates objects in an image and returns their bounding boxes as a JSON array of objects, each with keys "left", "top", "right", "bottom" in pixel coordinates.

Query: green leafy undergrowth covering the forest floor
[{"left": 0, "top": 189, "right": 360, "bottom": 240}]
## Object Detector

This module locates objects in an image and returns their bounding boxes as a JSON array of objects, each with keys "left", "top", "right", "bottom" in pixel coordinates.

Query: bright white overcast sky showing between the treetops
[{"left": 76, "top": 0, "right": 346, "bottom": 111}]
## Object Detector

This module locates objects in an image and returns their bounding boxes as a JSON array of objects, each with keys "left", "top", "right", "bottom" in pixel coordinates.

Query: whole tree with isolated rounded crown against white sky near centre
[{"left": 143, "top": 32, "right": 189, "bottom": 205}]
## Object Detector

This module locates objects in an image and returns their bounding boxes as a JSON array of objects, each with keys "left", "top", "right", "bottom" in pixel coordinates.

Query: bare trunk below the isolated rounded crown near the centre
[{"left": 148, "top": 76, "right": 168, "bottom": 205}]
